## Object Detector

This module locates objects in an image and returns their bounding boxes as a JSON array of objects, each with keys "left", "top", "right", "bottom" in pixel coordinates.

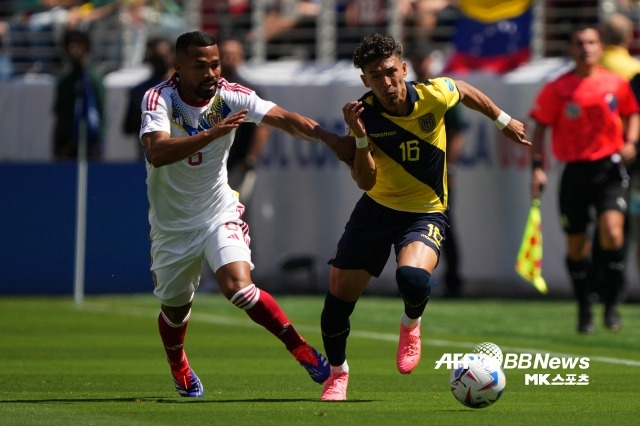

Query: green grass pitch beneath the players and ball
[{"left": 0, "top": 294, "right": 640, "bottom": 426}]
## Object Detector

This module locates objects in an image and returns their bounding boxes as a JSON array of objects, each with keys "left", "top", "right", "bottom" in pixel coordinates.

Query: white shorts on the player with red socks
[{"left": 151, "top": 208, "right": 254, "bottom": 307}]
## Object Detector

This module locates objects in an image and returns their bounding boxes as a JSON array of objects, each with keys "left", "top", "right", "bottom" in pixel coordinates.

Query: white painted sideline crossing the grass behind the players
[{"left": 81, "top": 302, "right": 640, "bottom": 367}]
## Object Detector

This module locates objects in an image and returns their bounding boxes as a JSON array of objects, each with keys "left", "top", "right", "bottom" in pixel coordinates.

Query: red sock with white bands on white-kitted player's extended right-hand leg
[{"left": 231, "top": 284, "right": 305, "bottom": 352}]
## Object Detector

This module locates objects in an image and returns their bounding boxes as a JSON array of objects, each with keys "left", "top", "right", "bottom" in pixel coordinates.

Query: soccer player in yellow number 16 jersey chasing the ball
[{"left": 321, "top": 34, "right": 530, "bottom": 401}]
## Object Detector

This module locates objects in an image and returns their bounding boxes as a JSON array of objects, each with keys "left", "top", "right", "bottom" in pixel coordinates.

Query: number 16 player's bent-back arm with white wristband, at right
[{"left": 456, "top": 80, "right": 531, "bottom": 146}]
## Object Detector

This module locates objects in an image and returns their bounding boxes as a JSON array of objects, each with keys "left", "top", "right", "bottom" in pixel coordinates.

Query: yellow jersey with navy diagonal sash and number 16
[{"left": 360, "top": 77, "right": 460, "bottom": 213}]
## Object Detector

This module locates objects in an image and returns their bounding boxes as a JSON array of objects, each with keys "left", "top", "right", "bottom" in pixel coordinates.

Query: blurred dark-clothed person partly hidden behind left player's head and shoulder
[{"left": 122, "top": 38, "right": 175, "bottom": 159}]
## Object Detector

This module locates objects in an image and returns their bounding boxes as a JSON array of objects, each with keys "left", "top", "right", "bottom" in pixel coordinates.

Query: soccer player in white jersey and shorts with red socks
[{"left": 140, "top": 31, "right": 355, "bottom": 397}]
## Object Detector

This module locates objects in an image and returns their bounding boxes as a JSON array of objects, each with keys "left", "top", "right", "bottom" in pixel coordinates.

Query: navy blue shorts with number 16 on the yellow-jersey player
[{"left": 328, "top": 194, "right": 449, "bottom": 277}]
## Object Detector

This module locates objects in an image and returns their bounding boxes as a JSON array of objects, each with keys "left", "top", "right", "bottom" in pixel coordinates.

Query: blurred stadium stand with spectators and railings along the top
[{"left": 0, "top": 0, "right": 640, "bottom": 78}]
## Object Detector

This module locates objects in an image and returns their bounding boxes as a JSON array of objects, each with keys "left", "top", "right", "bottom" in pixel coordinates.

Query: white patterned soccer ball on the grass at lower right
[{"left": 449, "top": 353, "right": 507, "bottom": 408}]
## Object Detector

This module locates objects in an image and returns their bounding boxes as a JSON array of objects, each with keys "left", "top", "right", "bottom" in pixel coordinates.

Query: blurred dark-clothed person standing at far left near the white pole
[{"left": 53, "top": 30, "right": 105, "bottom": 160}]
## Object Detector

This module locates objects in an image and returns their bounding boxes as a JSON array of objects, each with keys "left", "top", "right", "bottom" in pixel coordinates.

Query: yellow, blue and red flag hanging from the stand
[{"left": 444, "top": 0, "right": 533, "bottom": 73}]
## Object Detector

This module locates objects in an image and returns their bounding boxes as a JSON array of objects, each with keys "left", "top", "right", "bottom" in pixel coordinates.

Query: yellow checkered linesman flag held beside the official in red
[{"left": 516, "top": 198, "right": 547, "bottom": 294}]
